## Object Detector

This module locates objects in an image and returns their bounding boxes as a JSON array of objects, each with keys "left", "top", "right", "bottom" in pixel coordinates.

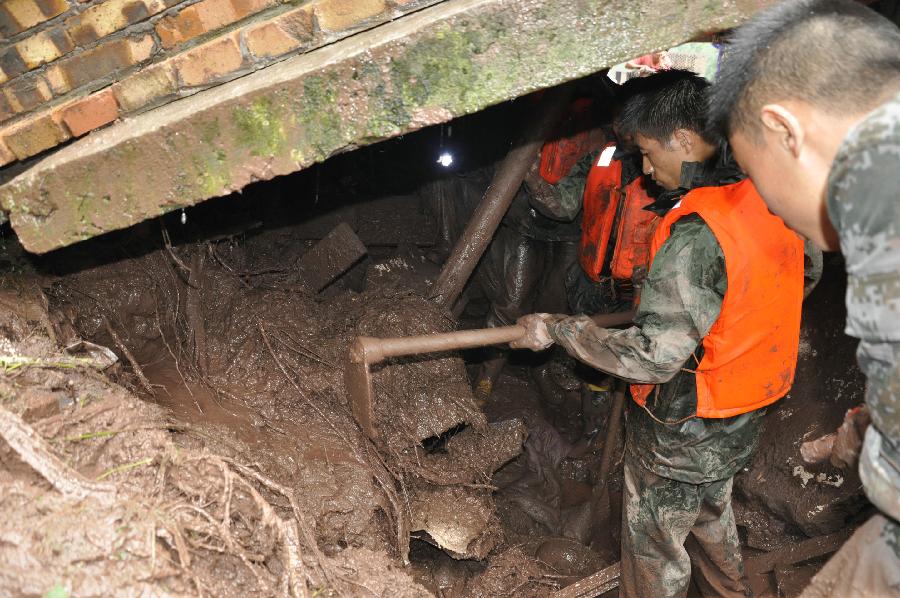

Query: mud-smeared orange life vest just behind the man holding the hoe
[{"left": 579, "top": 144, "right": 659, "bottom": 281}]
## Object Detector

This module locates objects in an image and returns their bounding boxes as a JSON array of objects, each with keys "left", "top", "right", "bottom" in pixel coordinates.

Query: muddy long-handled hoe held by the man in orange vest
[{"left": 344, "top": 311, "right": 634, "bottom": 440}]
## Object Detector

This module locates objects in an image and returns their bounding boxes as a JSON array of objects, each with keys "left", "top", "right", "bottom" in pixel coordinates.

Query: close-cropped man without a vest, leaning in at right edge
[{"left": 710, "top": 0, "right": 900, "bottom": 598}]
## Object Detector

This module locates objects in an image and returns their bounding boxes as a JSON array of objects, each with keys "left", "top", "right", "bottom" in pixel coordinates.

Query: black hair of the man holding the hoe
[{"left": 617, "top": 70, "right": 709, "bottom": 143}]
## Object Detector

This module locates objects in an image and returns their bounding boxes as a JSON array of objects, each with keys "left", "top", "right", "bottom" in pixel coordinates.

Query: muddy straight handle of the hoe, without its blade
[{"left": 350, "top": 311, "right": 634, "bottom": 365}]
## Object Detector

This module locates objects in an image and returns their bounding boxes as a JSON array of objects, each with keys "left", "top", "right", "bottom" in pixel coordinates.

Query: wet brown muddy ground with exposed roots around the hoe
[{"left": 0, "top": 122, "right": 867, "bottom": 597}]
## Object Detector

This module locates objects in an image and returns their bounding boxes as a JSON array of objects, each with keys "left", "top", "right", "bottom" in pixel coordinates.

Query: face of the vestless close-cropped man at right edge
[{"left": 729, "top": 123, "right": 838, "bottom": 250}]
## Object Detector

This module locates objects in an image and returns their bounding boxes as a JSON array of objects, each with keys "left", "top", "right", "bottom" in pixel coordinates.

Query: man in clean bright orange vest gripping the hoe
[{"left": 514, "top": 71, "right": 804, "bottom": 597}]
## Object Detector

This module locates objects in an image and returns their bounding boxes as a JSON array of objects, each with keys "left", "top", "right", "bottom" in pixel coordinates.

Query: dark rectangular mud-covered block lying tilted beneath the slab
[{"left": 297, "top": 222, "right": 367, "bottom": 293}]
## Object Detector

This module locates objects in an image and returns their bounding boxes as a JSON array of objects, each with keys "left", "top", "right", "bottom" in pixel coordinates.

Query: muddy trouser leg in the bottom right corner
[{"left": 800, "top": 515, "right": 900, "bottom": 598}]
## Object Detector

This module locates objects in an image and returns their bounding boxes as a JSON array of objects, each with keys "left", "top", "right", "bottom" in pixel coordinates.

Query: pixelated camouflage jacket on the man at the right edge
[{"left": 828, "top": 94, "right": 900, "bottom": 519}]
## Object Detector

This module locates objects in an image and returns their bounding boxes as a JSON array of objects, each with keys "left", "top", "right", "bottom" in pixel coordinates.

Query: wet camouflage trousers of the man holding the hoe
[{"left": 620, "top": 458, "right": 749, "bottom": 598}]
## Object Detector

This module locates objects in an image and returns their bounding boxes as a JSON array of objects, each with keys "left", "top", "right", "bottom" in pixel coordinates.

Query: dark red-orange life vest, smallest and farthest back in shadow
[{"left": 540, "top": 98, "right": 597, "bottom": 185}]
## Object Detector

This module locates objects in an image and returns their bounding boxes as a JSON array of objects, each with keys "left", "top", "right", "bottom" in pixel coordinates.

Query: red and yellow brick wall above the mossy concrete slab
[{"left": 0, "top": 0, "right": 441, "bottom": 167}]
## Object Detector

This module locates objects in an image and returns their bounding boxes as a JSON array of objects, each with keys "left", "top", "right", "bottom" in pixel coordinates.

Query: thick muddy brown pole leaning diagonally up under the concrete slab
[{"left": 429, "top": 85, "right": 572, "bottom": 312}]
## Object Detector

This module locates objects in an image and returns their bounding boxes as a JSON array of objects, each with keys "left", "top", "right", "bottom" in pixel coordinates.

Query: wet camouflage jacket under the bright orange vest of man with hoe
[{"left": 549, "top": 152, "right": 762, "bottom": 484}]
